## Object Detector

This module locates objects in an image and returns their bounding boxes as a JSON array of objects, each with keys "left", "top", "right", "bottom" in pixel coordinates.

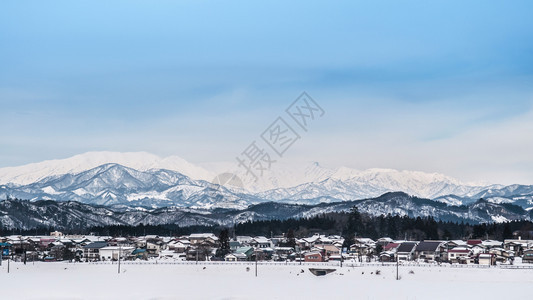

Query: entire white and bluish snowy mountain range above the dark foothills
[{"left": 0, "top": 152, "right": 533, "bottom": 209}]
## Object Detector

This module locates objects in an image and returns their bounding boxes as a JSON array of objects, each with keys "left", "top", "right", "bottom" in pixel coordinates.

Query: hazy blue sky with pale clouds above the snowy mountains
[{"left": 0, "top": 0, "right": 533, "bottom": 184}]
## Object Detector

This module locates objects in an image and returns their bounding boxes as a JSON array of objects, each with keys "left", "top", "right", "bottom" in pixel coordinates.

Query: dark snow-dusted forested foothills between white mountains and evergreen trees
[{"left": 0, "top": 192, "right": 533, "bottom": 230}]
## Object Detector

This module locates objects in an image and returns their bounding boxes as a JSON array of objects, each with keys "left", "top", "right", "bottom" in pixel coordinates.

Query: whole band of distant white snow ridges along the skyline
[{"left": 0, "top": 152, "right": 490, "bottom": 199}]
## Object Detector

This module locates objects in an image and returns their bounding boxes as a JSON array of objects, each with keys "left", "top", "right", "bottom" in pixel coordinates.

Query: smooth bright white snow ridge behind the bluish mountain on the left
[{"left": 0, "top": 151, "right": 214, "bottom": 185}]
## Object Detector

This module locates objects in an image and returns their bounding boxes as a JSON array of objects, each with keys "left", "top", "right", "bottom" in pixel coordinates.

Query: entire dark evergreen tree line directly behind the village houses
[{"left": 4, "top": 207, "right": 533, "bottom": 241}]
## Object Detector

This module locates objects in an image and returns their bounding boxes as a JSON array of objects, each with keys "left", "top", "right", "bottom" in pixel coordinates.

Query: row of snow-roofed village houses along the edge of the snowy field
[{"left": 0, "top": 232, "right": 533, "bottom": 264}]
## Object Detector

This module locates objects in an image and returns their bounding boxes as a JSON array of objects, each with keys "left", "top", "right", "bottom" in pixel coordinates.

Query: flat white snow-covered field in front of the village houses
[{"left": 0, "top": 261, "right": 533, "bottom": 299}]
